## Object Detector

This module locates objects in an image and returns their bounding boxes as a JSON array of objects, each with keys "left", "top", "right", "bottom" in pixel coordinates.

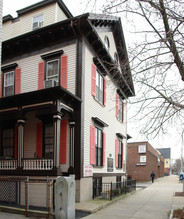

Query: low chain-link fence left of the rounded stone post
[{"left": 0, "top": 177, "right": 55, "bottom": 218}]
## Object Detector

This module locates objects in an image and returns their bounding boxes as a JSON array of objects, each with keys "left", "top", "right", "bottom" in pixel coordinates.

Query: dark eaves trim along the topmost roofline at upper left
[{"left": 3, "top": 0, "right": 73, "bottom": 23}]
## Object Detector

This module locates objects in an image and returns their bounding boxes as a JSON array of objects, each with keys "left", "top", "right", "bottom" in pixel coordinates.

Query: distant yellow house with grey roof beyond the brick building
[{"left": 157, "top": 148, "right": 171, "bottom": 175}]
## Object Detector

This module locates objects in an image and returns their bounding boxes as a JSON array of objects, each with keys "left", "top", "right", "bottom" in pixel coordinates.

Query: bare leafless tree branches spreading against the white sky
[{"left": 95, "top": 0, "right": 184, "bottom": 139}]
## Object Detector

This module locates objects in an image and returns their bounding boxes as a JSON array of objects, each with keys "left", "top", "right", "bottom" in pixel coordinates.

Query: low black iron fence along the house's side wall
[{"left": 93, "top": 179, "right": 136, "bottom": 200}]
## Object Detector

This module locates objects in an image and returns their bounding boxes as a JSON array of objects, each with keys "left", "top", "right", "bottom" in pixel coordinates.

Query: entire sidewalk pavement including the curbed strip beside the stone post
[{"left": 0, "top": 175, "right": 184, "bottom": 219}]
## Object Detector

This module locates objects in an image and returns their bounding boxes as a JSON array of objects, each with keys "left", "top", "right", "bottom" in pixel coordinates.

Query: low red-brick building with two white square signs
[{"left": 127, "top": 142, "right": 164, "bottom": 181}]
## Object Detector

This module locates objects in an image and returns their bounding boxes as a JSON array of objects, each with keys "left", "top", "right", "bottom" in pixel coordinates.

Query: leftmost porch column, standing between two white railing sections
[{"left": 17, "top": 119, "right": 25, "bottom": 168}]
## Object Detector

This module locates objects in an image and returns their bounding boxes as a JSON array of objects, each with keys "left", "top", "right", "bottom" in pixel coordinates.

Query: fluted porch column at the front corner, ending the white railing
[{"left": 53, "top": 114, "right": 62, "bottom": 168}]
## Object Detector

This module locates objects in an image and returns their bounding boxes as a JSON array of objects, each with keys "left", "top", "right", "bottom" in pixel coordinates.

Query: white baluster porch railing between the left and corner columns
[{"left": 23, "top": 158, "right": 53, "bottom": 170}]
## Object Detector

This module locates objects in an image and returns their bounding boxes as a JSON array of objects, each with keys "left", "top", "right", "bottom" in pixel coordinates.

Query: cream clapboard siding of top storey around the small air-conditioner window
[{"left": 2, "top": 3, "right": 57, "bottom": 41}]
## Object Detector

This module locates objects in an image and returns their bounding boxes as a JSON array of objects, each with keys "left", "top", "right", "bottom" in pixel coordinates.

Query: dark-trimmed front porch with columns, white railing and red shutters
[{"left": 0, "top": 87, "right": 79, "bottom": 176}]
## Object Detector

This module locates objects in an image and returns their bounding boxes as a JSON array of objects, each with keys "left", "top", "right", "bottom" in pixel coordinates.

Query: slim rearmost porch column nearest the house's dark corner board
[{"left": 69, "top": 122, "right": 75, "bottom": 172}]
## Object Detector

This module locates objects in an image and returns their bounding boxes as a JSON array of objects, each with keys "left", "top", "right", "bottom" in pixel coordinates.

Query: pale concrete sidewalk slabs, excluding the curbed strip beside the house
[{"left": 81, "top": 176, "right": 184, "bottom": 219}]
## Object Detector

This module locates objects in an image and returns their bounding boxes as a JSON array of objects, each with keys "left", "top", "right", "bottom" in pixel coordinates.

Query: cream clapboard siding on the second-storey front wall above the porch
[{"left": 1, "top": 43, "right": 76, "bottom": 94}]
